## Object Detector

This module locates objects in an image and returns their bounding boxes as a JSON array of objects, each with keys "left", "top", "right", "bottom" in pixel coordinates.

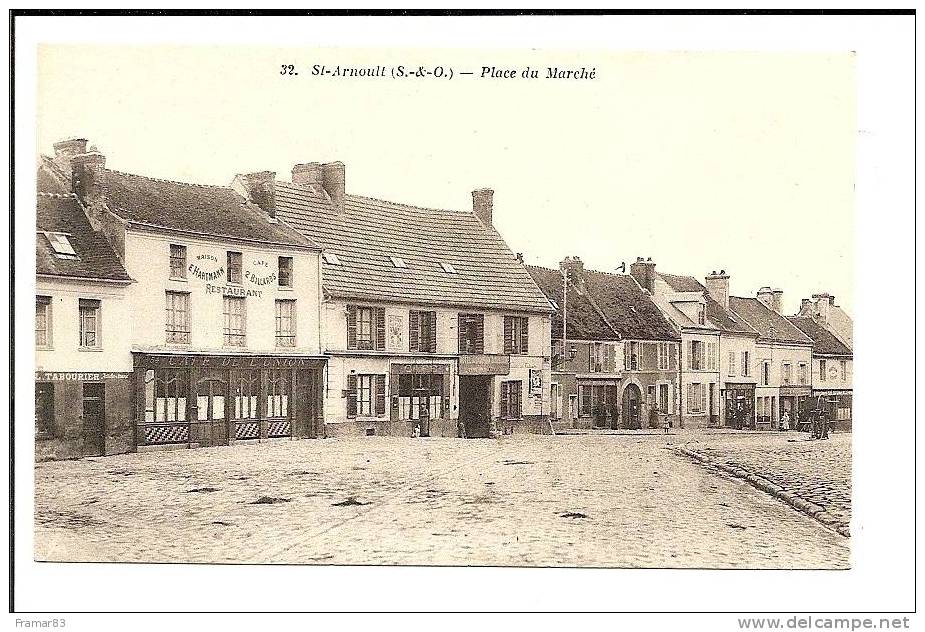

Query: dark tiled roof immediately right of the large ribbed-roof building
[{"left": 527, "top": 266, "right": 679, "bottom": 340}]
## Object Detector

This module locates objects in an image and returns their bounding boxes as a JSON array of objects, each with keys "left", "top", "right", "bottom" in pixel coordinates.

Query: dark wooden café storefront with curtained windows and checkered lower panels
[{"left": 132, "top": 352, "right": 325, "bottom": 450}]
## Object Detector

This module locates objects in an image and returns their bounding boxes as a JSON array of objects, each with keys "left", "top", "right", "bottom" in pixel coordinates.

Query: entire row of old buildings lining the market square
[{"left": 28, "top": 139, "right": 851, "bottom": 459}]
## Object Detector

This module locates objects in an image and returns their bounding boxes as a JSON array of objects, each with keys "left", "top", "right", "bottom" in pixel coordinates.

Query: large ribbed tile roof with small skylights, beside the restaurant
[{"left": 276, "top": 182, "right": 552, "bottom": 312}]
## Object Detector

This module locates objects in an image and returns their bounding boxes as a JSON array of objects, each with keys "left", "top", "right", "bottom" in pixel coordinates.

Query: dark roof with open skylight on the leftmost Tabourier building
[{"left": 35, "top": 167, "right": 132, "bottom": 282}]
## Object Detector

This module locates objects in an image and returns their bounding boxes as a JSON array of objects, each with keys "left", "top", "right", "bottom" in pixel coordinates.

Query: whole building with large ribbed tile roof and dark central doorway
[{"left": 233, "top": 162, "right": 552, "bottom": 437}]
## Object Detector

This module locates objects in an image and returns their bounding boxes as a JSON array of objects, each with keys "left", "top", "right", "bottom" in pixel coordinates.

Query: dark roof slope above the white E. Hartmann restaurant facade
[{"left": 106, "top": 169, "right": 317, "bottom": 248}]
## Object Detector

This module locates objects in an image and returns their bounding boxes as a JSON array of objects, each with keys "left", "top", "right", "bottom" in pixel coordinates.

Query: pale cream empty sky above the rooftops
[{"left": 37, "top": 45, "right": 856, "bottom": 313}]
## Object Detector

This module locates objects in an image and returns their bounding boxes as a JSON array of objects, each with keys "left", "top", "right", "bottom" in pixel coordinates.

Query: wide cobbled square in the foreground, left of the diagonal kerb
[{"left": 35, "top": 433, "right": 849, "bottom": 568}]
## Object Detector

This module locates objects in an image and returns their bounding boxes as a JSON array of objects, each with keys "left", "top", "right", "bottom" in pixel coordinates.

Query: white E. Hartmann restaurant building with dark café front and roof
[{"left": 44, "top": 139, "right": 325, "bottom": 450}]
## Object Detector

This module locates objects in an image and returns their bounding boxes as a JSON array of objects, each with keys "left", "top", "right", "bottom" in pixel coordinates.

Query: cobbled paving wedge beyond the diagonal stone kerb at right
[{"left": 687, "top": 432, "right": 851, "bottom": 528}]
